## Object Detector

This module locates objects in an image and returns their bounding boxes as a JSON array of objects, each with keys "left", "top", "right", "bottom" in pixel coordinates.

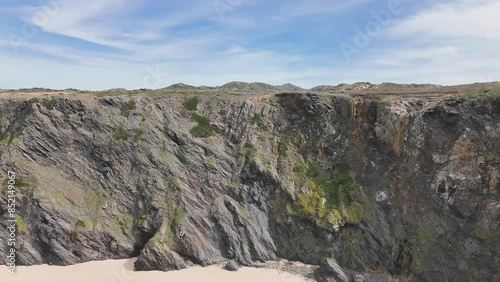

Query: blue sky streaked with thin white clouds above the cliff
[{"left": 0, "top": 0, "right": 500, "bottom": 90}]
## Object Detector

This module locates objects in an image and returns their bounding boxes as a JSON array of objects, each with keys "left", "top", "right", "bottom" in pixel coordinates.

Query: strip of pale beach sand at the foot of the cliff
[{"left": 0, "top": 259, "right": 307, "bottom": 282}]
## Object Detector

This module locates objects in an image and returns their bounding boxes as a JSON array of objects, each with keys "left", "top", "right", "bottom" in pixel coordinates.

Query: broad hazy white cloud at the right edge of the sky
[{"left": 358, "top": 0, "right": 500, "bottom": 85}]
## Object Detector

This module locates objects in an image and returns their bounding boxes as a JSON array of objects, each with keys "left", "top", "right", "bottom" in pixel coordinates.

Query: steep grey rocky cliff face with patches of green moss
[{"left": 0, "top": 87, "right": 500, "bottom": 281}]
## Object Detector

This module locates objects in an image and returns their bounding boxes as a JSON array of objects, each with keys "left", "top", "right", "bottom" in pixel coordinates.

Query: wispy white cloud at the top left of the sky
[{"left": 13, "top": 0, "right": 220, "bottom": 51}]
